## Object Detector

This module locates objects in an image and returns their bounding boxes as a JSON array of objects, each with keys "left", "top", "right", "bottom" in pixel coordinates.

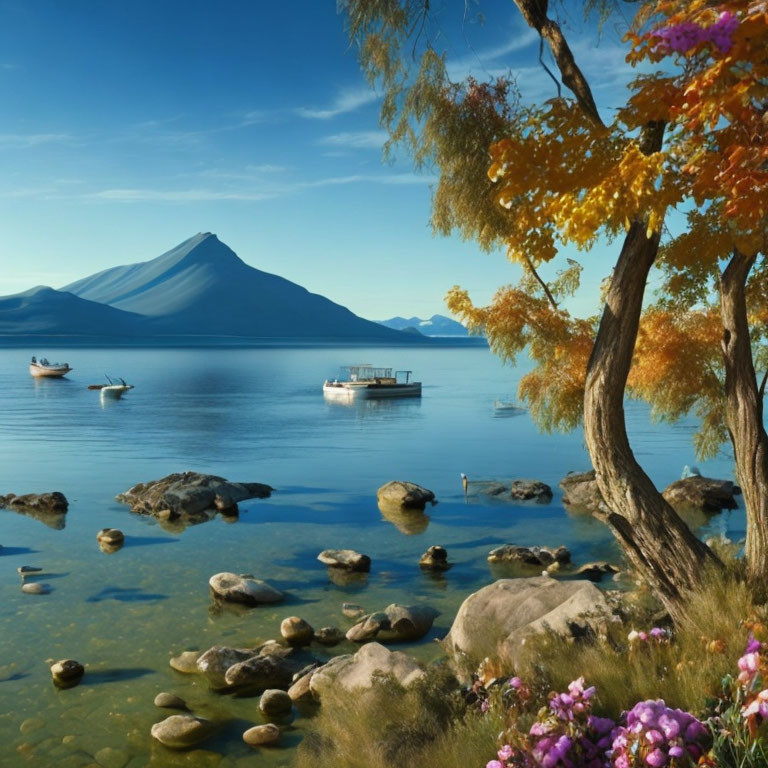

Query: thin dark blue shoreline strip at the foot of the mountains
[{"left": 0, "top": 334, "right": 488, "bottom": 349}]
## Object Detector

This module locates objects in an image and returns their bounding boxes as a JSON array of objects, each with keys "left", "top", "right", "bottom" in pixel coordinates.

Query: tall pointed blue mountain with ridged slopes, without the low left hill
[{"left": 62, "top": 232, "right": 414, "bottom": 343}]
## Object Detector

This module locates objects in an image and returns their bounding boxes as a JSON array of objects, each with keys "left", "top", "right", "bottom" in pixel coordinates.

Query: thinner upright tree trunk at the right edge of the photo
[{"left": 720, "top": 250, "right": 768, "bottom": 589}]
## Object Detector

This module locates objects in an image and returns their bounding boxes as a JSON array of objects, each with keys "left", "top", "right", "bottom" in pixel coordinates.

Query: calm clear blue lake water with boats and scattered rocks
[{"left": 0, "top": 346, "right": 744, "bottom": 768}]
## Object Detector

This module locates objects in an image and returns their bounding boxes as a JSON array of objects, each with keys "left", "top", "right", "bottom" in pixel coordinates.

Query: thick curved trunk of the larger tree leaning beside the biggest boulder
[{"left": 584, "top": 124, "right": 719, "bottom": 616}]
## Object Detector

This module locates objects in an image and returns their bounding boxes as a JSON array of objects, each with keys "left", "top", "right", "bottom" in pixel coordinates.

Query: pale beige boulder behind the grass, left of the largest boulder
[{"left": 309, "top": 643, "right": 424, "bottom": 699}]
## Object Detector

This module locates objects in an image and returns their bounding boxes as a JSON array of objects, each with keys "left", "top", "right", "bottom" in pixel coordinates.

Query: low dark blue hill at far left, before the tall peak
[{"left": 0, "top": 285, "right": 152, "bottom": 337}]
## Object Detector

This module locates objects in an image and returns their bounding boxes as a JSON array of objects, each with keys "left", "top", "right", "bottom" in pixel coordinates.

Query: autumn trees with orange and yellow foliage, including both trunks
[{"left": 342, "top": 0, "right": 768, "bottom": 610}]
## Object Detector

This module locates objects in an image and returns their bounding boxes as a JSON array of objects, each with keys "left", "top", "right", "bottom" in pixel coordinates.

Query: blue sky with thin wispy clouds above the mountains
[{"left": 0, "top": 0, "right": 648, "bottom": 319}]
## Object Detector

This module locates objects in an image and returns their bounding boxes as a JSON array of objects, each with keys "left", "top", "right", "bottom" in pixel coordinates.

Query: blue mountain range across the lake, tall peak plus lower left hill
[{"left": 0, "top": 232, "right": 418, "bottom": 343}]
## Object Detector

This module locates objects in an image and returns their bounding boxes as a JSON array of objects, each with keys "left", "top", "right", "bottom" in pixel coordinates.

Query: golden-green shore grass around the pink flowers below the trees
[{"left": 297, "top": 574, "right": 768, "bottom": 768}]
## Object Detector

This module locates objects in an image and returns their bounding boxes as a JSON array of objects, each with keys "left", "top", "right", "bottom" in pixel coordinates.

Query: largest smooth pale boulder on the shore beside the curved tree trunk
[{"left": 443, "top": 576, "right": 611, "bottom": 676}]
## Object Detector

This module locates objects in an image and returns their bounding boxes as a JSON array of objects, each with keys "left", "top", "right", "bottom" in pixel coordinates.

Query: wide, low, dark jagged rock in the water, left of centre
[{"left": 116, "top": 472, "right": 273, "bottom": 522}]
